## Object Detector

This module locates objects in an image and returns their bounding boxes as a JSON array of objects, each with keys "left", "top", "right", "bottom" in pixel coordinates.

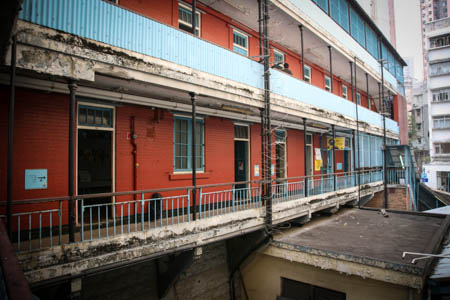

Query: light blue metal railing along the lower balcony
[{"left": 0, "top": 169, "right": 383, "bottom": 252}]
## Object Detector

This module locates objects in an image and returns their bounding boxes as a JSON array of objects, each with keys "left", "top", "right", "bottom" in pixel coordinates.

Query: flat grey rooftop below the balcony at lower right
[{"left": 273, "top": 209, "right": 450, "bottom": 280}]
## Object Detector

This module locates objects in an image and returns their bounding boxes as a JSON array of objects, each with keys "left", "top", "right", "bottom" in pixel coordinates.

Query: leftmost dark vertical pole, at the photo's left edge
[{"left": 6, "top": 35, "right": 17, "bottom": 239}]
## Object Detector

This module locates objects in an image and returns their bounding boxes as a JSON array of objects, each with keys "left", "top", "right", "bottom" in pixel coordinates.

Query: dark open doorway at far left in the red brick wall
[{"left": 78, "top": 129, "right": 112, "bottom": 210}]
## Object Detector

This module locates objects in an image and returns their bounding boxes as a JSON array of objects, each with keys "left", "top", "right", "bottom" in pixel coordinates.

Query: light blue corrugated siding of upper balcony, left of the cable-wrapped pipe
[{"left": 19, "top": 0, "right": 263, "bottom": 89}]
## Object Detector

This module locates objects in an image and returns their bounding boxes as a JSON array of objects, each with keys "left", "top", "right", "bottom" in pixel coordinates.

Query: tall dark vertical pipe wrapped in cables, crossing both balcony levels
[{"left": 263, "top": 0, "right": 272, "bottom": 237}]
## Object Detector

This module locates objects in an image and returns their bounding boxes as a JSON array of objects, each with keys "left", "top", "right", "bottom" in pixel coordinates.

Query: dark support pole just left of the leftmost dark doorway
[{"left": 69, "top": 81, "right": 78, "bottom": 243}]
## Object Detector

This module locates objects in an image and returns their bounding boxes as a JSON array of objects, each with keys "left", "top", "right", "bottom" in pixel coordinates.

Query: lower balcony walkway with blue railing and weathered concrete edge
[{"left": 2, "top": 170, "right": 383, "bottom": 284}]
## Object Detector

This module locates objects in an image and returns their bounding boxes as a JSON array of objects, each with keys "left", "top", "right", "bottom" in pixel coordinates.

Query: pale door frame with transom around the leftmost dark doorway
[{"left": 75, "top": 100, "right": 116, "bottom": 225}]
